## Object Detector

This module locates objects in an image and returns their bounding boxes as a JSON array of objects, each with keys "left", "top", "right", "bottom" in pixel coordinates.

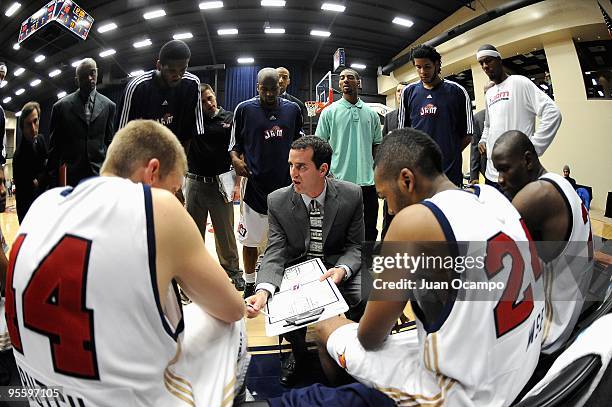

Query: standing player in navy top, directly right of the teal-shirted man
[{"left": 398, "top": 44, "right": 474, "bottom": 185}]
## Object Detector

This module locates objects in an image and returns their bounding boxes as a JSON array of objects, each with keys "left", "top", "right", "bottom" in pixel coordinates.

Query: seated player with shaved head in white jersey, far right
[{"left": 492, "top": 130, "right": 594, "bottom": 354}]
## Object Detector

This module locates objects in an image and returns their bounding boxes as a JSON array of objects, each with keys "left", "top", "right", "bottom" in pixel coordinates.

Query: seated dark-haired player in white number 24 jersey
[{"left": 318, "top": 128, "right": 544, "bottom": 406}]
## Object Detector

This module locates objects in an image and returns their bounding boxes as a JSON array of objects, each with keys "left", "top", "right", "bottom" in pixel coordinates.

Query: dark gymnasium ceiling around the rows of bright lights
[{"left": 0, "top": 0, "right": 471, "bottom": 111}]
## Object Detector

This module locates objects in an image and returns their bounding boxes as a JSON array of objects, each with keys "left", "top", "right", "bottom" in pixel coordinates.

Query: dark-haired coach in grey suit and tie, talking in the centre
[{"left": 246, "top": 136, "right": 365, "bottom": 385}]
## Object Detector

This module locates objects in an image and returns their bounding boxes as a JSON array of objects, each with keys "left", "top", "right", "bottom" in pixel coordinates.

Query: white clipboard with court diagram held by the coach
[{"left": 266, "top": 259, "right": 349, "bottom": 336}]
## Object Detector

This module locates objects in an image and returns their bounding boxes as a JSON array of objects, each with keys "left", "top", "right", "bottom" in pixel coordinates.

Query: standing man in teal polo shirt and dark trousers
[{"left": 315, "top": 69, "right": 382, "bottom": 241}]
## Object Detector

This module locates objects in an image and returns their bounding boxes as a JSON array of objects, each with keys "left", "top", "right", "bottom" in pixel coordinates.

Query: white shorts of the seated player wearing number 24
[{"left": 327, "top": 323, "right": 458, "bottom": 405}]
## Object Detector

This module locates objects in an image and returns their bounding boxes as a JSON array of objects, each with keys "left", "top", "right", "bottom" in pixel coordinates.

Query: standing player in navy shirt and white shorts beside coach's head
[{"left": 229, "top": 68, "right": 303, "bottom": 298}]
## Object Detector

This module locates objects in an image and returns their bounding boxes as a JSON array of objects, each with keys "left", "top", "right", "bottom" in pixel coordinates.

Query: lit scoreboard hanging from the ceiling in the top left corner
[{"left": 18, "top": 0, "right": 94, "bottom": 44}]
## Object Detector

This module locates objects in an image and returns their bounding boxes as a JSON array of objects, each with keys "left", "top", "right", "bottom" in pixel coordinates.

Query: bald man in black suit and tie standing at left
[{"left": 47, "top": 58, "right": 116, "bottom": 186}]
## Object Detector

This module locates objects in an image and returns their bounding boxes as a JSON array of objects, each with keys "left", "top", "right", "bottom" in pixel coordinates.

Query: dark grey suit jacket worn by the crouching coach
[{"left": 257, "top": 178, "right": 364, "bottom": 305}]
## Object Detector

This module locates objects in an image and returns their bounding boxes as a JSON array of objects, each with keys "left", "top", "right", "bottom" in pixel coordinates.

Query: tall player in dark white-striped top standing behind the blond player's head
[{"left": 117, "top": 40, "right": 204, "bottom": 148}]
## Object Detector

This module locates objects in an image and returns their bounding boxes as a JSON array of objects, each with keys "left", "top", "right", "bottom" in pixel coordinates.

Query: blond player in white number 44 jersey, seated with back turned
[{"left": 6, "top": 120, "right": 245, "bottom": 407}]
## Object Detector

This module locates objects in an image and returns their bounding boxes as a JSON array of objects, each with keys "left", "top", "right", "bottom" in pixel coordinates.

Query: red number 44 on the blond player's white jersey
[{"left": 6, "top": 235, "right": 99, "bottom": 379}]
